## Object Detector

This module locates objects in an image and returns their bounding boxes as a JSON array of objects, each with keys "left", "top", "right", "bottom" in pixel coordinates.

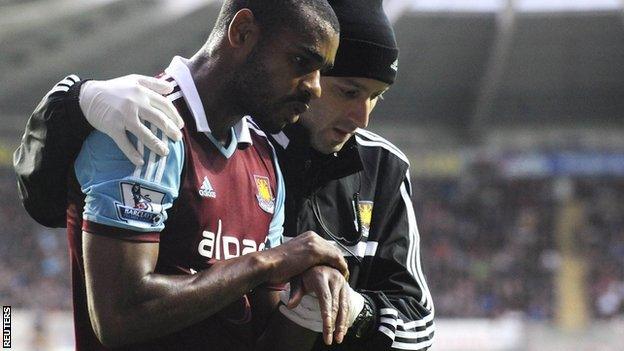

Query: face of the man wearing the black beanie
[{"left": 301, "top": 77, "right": 389, "bottom": 154}]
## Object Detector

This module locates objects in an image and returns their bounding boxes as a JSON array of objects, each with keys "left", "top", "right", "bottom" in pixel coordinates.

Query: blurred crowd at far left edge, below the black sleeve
[{"left": 0, "top": 167, "right": 71, "bottom": 310}]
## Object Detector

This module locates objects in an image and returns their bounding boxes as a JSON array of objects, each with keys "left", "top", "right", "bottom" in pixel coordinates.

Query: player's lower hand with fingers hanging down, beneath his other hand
[{"left": 287, "top": 266, "right": 350, "bottom": 345}]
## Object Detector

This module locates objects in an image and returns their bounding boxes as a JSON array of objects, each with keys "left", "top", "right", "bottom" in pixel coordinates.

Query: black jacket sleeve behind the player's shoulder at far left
[{"left": 13, "top": 75, "right": 92, "bottom": 227}]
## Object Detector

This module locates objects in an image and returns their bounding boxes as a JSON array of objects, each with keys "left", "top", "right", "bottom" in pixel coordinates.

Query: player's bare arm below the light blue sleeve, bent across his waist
[{"left": 83, "top": 232, "right": 348, "bottom": 347}]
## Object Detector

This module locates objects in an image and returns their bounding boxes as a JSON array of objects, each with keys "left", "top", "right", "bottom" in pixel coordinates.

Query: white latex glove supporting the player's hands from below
[{"left": 279, "top": 286, "right": 364, "bottom": 333}]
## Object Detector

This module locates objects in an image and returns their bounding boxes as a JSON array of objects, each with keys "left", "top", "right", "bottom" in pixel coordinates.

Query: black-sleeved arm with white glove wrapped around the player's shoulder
[{"left": 13, "top": 75, "right": 183, "bottom": 227}]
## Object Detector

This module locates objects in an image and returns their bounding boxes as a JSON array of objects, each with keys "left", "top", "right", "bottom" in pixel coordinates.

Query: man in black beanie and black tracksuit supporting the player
[{"left": 14, "top": 0, "right": 434, "bottom": 350}]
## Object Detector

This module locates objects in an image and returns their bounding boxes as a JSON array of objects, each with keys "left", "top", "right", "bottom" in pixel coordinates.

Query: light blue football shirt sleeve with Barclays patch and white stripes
[{"left": 74, "top": 126, "right": 184, "bottom": 242}]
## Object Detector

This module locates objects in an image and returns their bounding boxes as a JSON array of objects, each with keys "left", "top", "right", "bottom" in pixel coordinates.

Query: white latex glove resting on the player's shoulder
[{"left": 79, "top": 74, "right": 184, "bottom": 166}]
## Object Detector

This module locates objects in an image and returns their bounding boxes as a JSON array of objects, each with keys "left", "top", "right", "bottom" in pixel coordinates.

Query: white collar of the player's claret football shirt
[{"left": 165, "top": 56, "right": 253, "bottom": 146}]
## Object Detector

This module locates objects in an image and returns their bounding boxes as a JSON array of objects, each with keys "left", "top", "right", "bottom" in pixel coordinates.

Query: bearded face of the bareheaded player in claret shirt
[{"left": 235, "top": 30, "right": 339, "bottom": 133}]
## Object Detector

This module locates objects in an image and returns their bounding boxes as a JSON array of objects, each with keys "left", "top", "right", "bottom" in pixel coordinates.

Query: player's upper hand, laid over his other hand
[{"left": 261, "top": 231, "right": 349, "bottom": 284}]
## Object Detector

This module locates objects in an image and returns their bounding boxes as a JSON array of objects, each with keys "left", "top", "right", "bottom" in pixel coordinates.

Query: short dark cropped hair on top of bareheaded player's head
[{"left": 212, "top": 0, "right": 340, "bottom": 41}]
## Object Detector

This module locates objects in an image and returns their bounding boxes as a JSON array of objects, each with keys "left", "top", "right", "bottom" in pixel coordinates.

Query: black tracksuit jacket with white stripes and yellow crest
[{"left": 14, "top": 76, "right": 434, "bottom": 350}]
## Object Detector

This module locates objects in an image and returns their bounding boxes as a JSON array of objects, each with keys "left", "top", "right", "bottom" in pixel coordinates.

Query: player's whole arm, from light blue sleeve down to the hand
[{"left": 76, "top": 132, "right": 347, "bottom": 346}]
